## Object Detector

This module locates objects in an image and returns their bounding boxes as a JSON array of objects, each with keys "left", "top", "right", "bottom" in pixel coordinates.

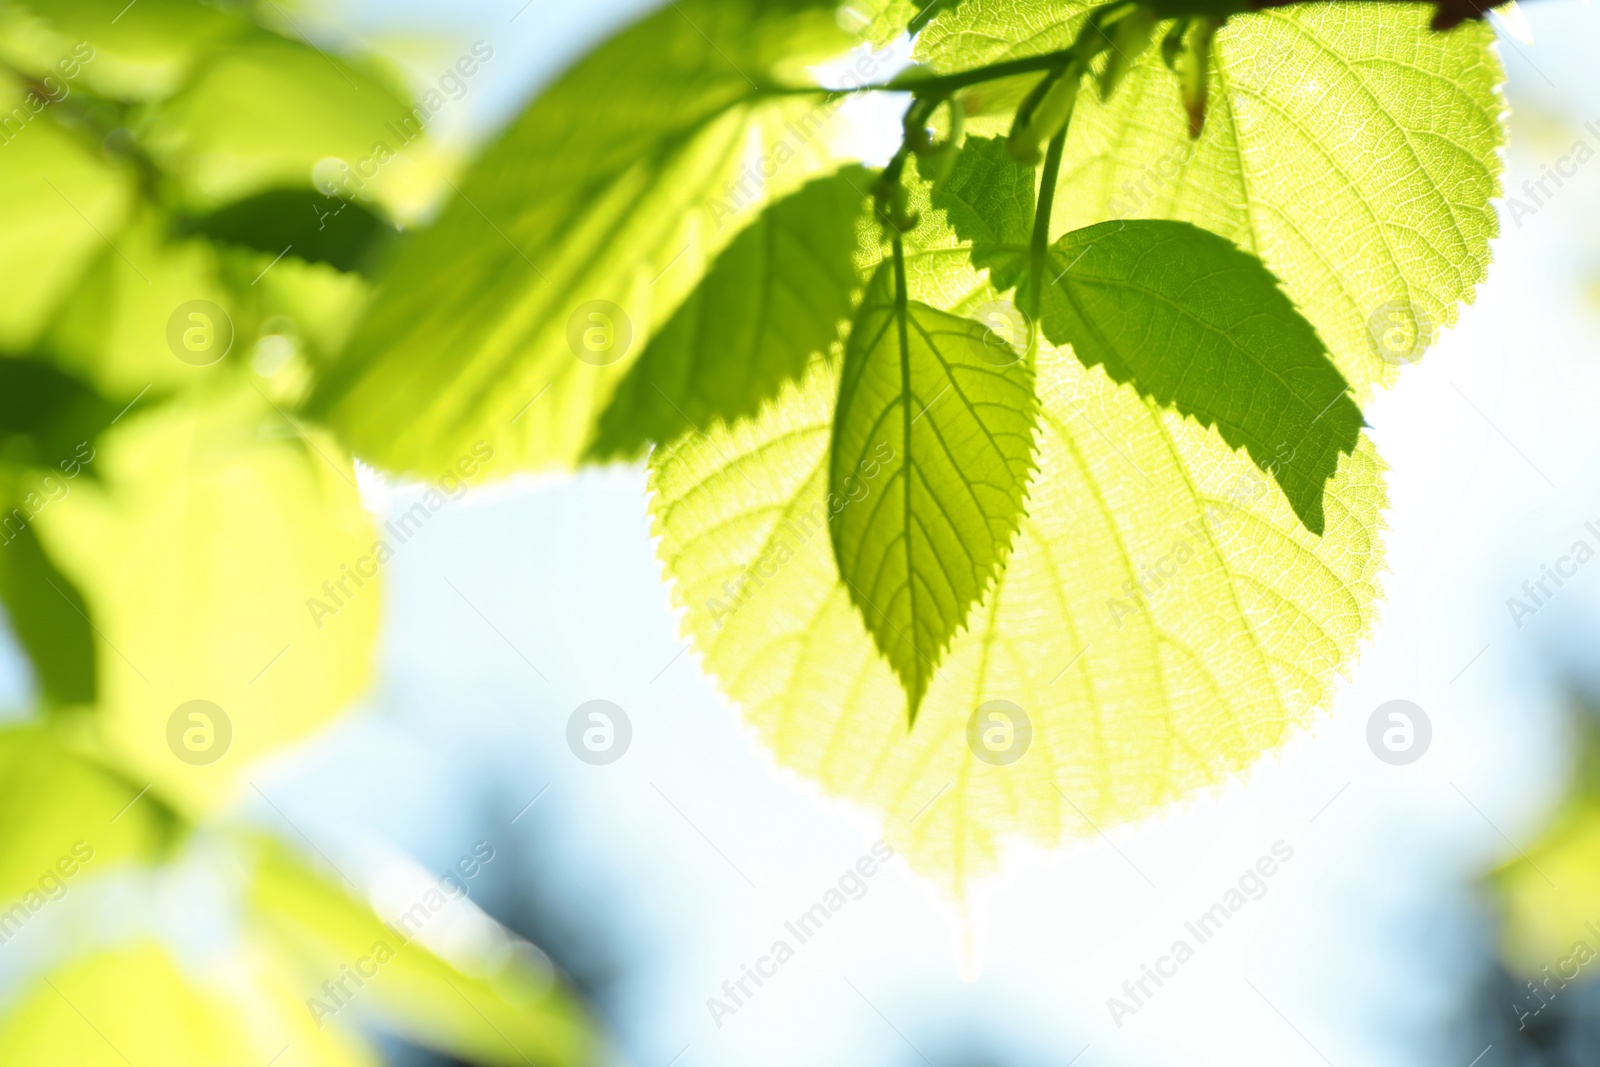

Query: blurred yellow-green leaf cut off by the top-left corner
[{"left": 0, "top": 0, "right": 250, "bottom": 101}]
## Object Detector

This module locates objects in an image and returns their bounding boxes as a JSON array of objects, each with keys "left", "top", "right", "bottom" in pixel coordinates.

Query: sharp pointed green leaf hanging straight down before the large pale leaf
[{"left": 829, "top": 262, "right": 1038, "bottom": 723}]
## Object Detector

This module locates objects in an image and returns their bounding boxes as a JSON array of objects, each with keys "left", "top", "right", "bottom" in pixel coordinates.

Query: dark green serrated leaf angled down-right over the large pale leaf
[{"left": 1024, "top": 221, "right": 1362, "bottom": 534}]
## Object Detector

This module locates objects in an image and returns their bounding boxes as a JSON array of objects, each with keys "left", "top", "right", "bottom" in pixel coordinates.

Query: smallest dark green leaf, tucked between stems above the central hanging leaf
[{"left": 918, "top": 138, "right": 1037, "bottom": 291}]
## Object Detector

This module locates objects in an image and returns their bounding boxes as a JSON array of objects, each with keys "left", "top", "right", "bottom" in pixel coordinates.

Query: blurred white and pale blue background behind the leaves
[{"left": 0, "top": 0, "right": 1600, "bottom": 1067}]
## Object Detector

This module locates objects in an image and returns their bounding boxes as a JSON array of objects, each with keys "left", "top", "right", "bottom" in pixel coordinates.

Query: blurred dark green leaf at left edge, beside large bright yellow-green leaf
[{"left": 0, "top": 524, "right": 96, "bottom": 710}]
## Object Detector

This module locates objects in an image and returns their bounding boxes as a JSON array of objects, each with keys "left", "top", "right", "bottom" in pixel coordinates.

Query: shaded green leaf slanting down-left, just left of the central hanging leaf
[{"left": 589, "top": 166, "right": 872, "bottom": 459}]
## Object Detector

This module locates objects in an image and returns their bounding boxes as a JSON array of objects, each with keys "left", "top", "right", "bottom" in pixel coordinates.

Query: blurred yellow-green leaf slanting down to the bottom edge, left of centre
[{"left": 253, "top": 845, "right": 600, "bottom": 1067}]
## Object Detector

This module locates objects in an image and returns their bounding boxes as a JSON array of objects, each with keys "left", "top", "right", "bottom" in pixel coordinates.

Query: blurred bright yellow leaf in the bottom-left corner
[{"left": 0, "top": 941, "right": 381, "bottom": 1067}]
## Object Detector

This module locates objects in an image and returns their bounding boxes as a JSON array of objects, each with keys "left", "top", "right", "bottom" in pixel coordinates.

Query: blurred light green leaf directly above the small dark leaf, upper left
[{"left": 142, "top": 37, "right": 426, "bottom": 211}]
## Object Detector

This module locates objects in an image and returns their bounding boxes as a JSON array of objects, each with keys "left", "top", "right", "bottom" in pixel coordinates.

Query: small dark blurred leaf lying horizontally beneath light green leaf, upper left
[{"left": 181, "top": 187, "right": 397, "bottom": 278}]
